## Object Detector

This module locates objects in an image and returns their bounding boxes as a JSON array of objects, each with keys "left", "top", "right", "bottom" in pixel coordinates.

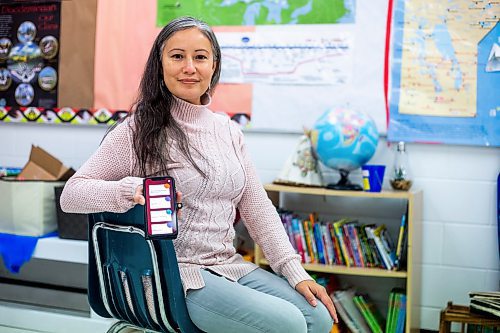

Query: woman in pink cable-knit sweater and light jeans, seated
[{"left": 61, "top": 17, "right": 337, "bottom": 333}]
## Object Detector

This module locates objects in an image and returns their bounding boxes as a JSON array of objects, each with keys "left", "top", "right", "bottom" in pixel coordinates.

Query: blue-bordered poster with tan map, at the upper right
[{"left": 388, "top": 0, "right": 500, "bottom": 146}]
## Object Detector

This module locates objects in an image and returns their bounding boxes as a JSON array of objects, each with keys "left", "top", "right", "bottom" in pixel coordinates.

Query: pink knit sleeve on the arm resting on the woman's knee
[{"left": 231, "top": 125, "right": 312, "bottom": 288}]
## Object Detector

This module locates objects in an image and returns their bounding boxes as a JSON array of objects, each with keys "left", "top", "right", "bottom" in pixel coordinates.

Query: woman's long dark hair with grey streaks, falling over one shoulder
[{"left": 133, "top": 16, "right": 221, "bottom": 176}]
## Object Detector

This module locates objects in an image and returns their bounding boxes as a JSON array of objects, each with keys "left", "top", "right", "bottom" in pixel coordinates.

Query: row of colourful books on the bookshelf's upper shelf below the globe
[{"left": 280, "top": 211, "right": 408, "bottom": 270}]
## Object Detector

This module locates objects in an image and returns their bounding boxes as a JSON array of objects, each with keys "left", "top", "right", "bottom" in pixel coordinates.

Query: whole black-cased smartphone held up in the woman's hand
[{"left": 143, "top": 176, "right": 178, "bottom": 239}]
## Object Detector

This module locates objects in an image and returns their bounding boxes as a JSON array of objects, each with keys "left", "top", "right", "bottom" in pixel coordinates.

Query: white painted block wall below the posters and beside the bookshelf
[{"left": 0, "top": 123, "right": 500, "bottom": 330}]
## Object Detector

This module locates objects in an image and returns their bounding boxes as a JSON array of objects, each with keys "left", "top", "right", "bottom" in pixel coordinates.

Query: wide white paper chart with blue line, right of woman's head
[{"left": 217, "top": 27, "right": 353, "bottom": 86}]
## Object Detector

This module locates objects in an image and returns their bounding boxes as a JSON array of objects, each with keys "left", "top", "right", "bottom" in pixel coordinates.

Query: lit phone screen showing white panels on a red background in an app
[{"left": 145, "top": 178, "right": 176, "bottom": 235}]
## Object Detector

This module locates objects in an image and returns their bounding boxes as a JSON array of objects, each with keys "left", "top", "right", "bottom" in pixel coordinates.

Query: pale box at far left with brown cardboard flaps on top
[{"left": 0, "top": 146, "right": 75, "bottom": 236}]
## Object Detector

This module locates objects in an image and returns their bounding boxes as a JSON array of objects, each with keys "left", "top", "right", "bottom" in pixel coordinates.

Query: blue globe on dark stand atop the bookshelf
[{"left": 311, "top": 108, "right": 378, "bottom": 191}]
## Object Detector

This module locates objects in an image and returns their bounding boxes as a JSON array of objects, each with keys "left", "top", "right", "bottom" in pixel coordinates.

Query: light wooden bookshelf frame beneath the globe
[{"left": 254, "top": 184, "right": 423, "bottom": 333}]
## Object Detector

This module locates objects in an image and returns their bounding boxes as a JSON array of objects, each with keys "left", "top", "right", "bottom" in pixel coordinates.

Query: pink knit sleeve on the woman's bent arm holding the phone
[{"left": 61, "top": 118, "right": 142, "bottom": 214}]
